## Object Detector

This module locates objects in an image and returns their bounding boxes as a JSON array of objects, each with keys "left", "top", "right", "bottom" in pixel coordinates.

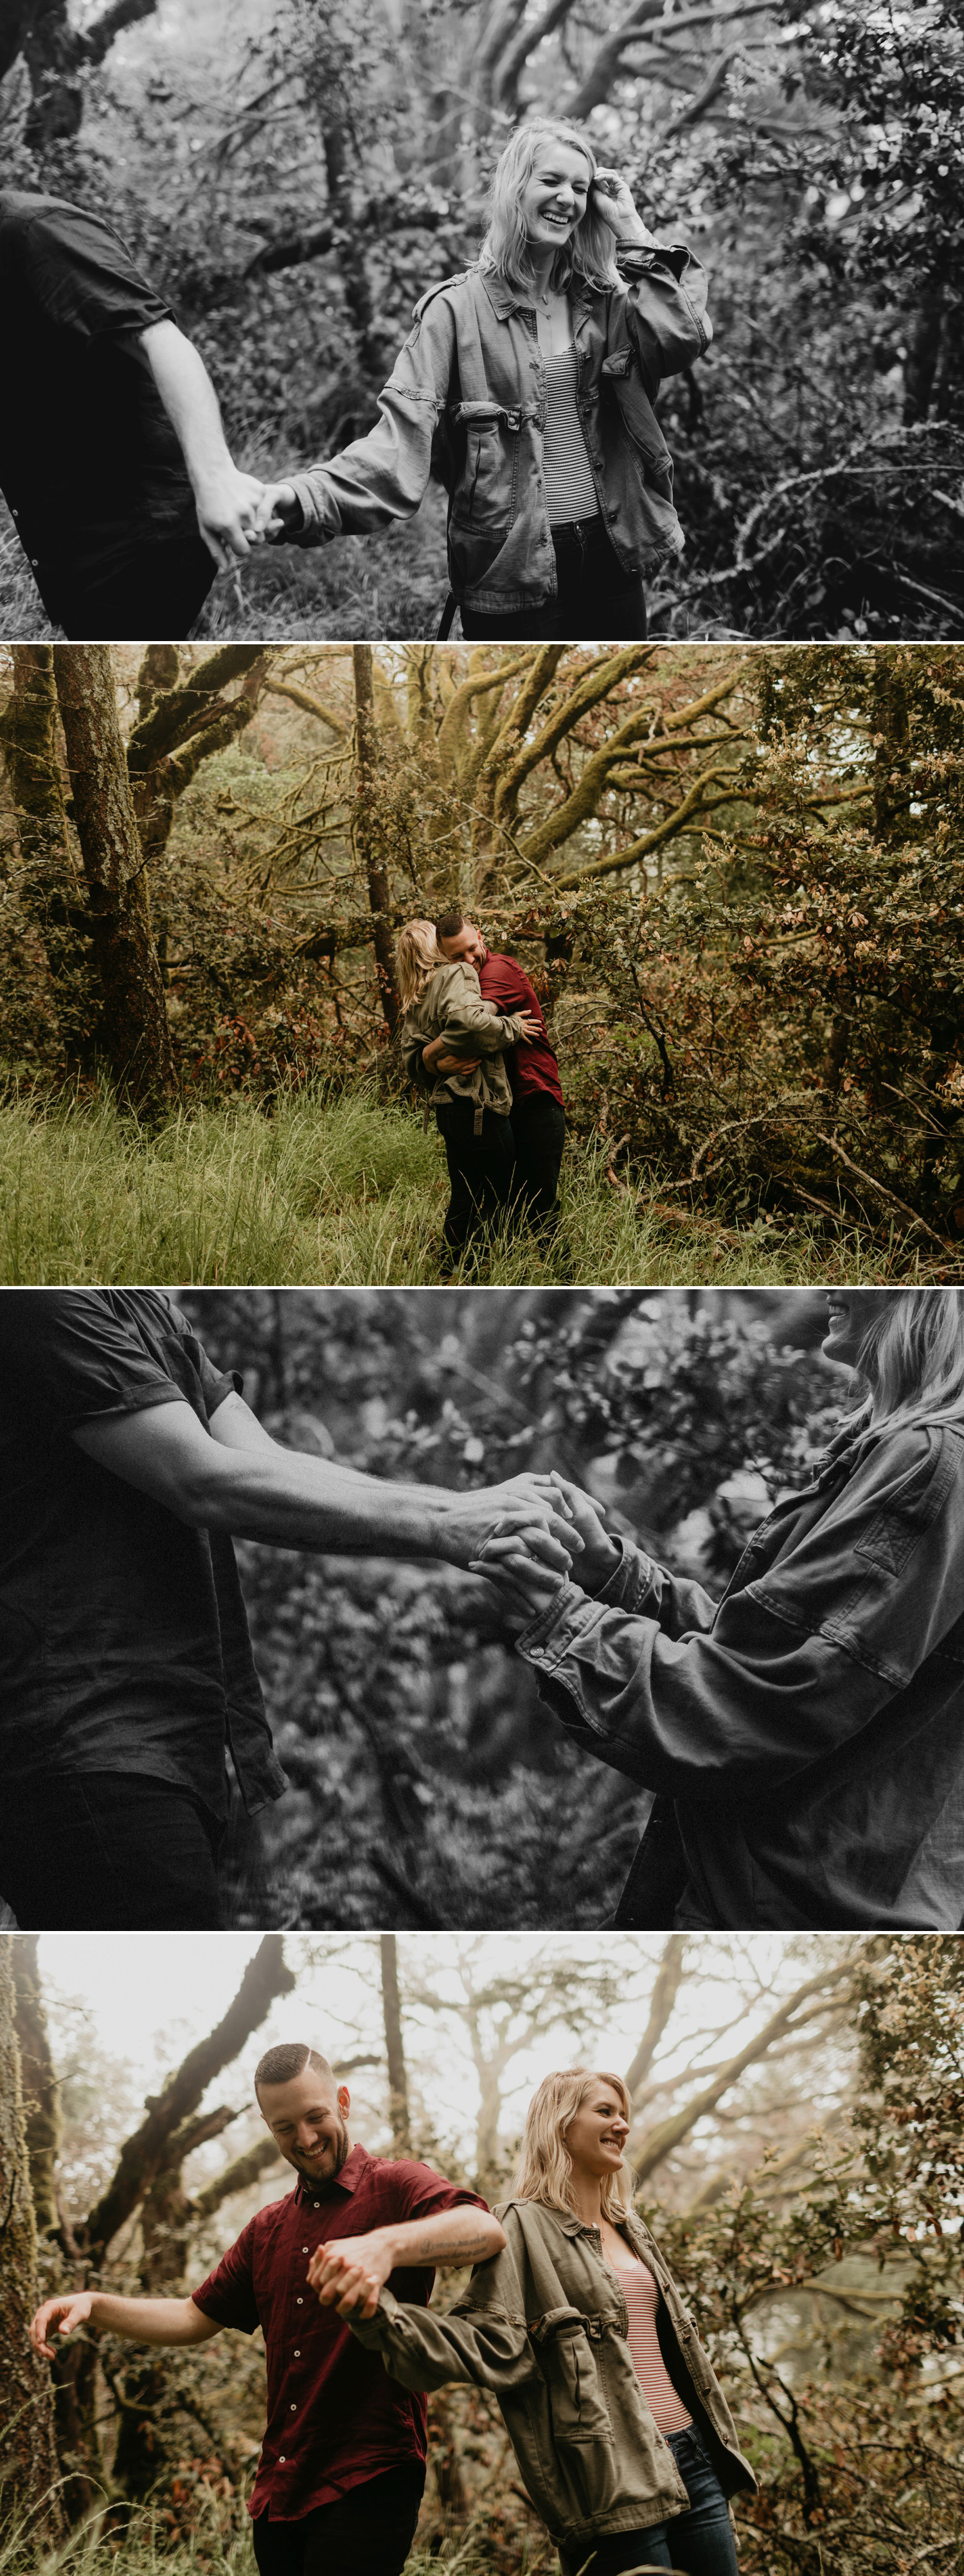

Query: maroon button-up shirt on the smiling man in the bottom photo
[{"left": 191, "top": 2146, "right": 487, "bottom": 2522}]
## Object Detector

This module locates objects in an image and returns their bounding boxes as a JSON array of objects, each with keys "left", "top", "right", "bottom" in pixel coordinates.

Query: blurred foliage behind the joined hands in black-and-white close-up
[{"left": 183, "top": 1288, "right": 848, "bottom": 1929}]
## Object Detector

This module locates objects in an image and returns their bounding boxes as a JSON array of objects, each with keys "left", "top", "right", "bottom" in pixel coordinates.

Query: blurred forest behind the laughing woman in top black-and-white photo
[{"left": 0, "top": 0, "right": 964, "bottom": 639}]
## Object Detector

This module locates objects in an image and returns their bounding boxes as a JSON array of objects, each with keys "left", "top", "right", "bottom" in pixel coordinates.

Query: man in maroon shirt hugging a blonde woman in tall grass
[{"left": 423, "top": 912, "right": 564, "bottom": 1234}]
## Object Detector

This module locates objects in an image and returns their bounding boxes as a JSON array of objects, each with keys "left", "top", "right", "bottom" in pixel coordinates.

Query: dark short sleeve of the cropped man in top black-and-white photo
[{"left": 21, "top": 206, "right": 173, "bottom": 350}]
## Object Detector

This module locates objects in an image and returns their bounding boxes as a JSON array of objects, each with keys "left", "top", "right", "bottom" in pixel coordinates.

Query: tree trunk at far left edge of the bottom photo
[{"left": 0, "top": 1932, "right": 64, "bottom": 2543}]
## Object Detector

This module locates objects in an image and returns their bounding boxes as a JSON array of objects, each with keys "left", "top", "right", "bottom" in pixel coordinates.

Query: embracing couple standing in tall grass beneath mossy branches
[{"left": 397, "top": 912, "right": 564, "bottom": 1257}]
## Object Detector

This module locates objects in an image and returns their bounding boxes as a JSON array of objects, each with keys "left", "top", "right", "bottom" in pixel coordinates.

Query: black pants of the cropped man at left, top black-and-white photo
[{"left": 41, "top": 536, "right": 217, "bottom": 644}]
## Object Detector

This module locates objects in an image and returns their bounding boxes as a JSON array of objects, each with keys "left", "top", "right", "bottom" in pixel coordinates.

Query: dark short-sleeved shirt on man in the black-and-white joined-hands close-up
[{"left": 0, "top": 1288, "right": 286, "bottom": 1819}]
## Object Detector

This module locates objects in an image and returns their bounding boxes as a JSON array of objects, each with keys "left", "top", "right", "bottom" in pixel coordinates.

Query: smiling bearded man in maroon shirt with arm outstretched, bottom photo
[{"left": 31, "top": 2045, "right": 505, "bottom": 2576}]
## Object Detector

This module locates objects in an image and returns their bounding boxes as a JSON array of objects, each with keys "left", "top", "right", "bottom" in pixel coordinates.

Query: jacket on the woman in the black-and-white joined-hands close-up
[{"left": 518, "top": 1422, "right": 964, "bottom": 1932}]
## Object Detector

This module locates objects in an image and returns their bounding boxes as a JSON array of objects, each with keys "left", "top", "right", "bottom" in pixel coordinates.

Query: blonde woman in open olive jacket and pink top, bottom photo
[{"left": 307, "top": 2066, "right": 755, "bottom": 2576}]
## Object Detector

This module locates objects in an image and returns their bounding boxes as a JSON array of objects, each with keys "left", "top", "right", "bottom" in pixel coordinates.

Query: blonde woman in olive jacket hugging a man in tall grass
[{"left": 395, "top": 922, "right": 541, "bottom": 1255}]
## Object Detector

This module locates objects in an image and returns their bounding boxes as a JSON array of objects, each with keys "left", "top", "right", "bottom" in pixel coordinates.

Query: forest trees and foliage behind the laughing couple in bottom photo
[{"left": 0, "top": 1935, "right": 964, "bottom": 2576}]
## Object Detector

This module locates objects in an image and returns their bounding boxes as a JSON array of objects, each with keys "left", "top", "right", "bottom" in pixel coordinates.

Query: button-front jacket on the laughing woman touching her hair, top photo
[{"left": 291, "top": 242, "right": 711, "bottom": 615}]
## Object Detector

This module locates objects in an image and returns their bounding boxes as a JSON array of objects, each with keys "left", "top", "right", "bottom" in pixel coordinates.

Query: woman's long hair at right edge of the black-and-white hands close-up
[{"left": 856, "top": 1288, "right": 964, "bottom": 1433}]
